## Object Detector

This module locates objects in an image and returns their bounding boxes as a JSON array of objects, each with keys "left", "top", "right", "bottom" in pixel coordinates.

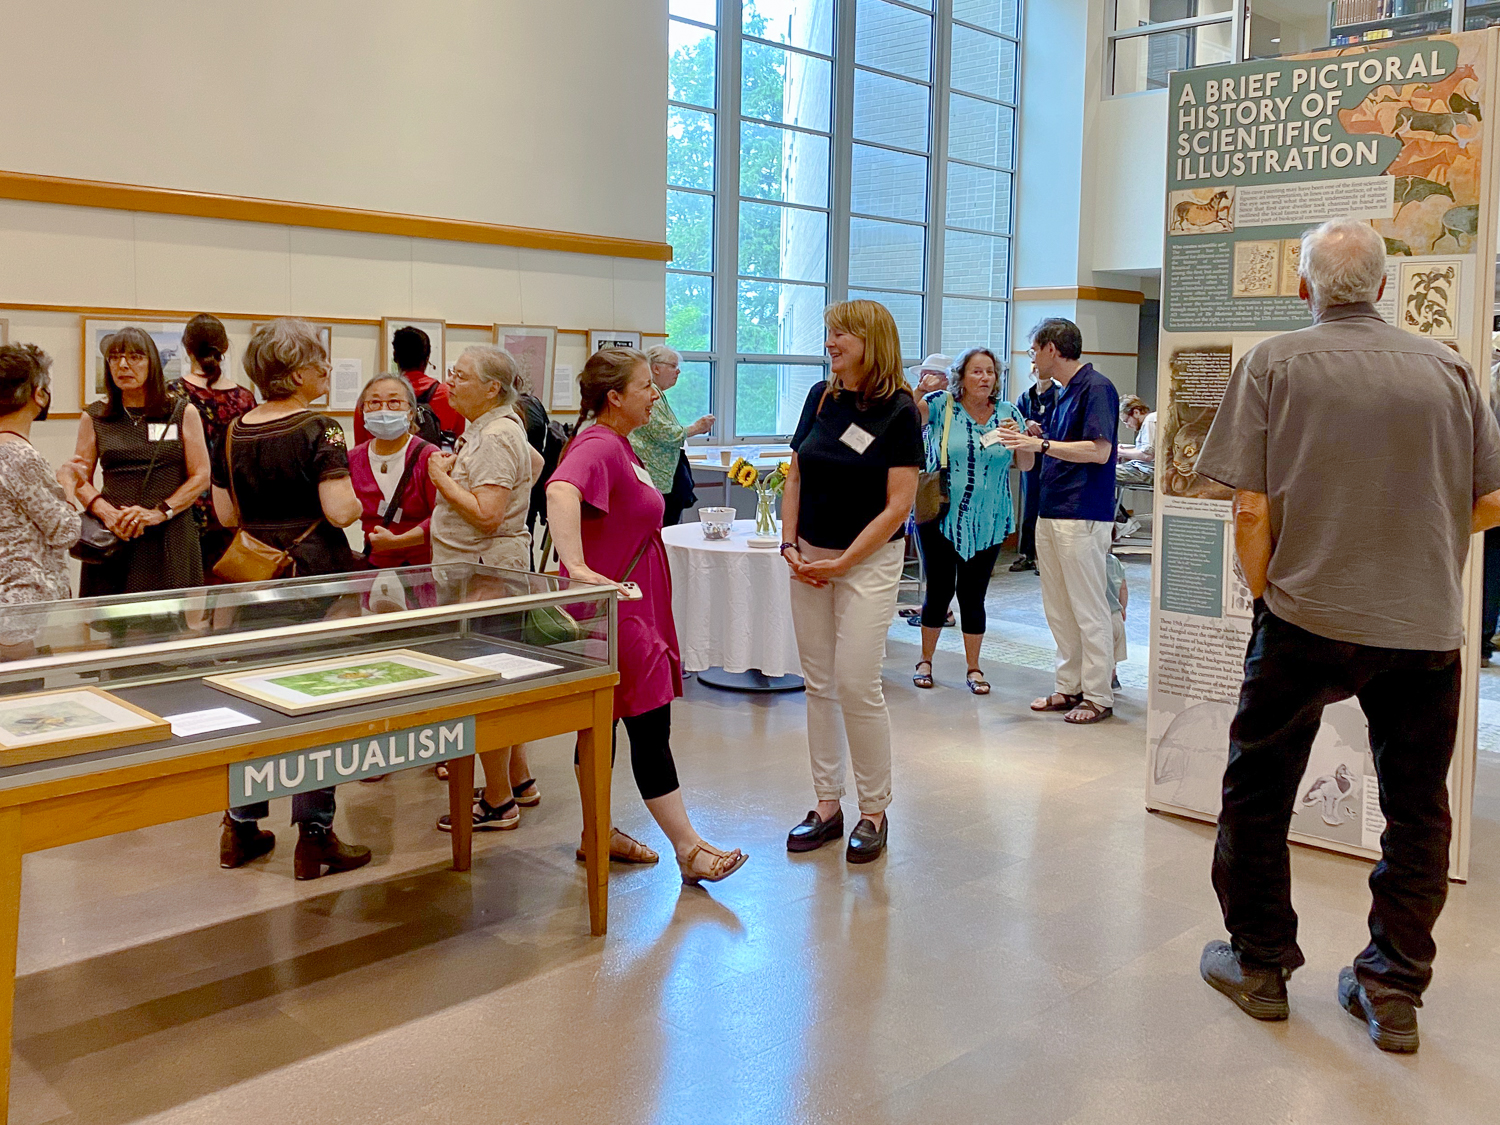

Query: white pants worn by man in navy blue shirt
[{"left": 1037, "top": 519, "right": 1115, "bottom": 707}]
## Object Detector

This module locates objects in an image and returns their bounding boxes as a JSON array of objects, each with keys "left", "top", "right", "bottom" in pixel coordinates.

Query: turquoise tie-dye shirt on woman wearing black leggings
[{"left": 924, "top": 390, "right": 1026, "bottom": 558}]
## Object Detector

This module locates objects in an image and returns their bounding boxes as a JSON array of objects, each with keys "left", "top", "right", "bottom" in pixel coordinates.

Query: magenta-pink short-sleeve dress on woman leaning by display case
[{"left": 552, "top": 425, "right": 683, "bottom": 719}]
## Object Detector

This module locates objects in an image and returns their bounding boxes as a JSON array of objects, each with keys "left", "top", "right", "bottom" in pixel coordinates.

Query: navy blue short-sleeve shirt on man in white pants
[{"left": 1038, "top": 363, "right": 1121, "bottom": 522}]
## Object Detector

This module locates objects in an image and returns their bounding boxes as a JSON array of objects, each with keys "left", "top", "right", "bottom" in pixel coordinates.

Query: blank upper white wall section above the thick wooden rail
[{"left": 0, "top": 0, "right": 666, "bottom": 240}]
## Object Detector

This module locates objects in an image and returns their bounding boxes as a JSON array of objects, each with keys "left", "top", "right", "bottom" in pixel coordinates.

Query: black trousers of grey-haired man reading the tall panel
[{"left": 1214, "top": 602, "right": 1460, "bottom": 1004}]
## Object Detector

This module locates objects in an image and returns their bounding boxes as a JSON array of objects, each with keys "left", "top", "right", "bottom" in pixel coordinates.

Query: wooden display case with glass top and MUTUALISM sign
[{"left": 0, "top": 573, "right": 618, "bottom": 1124}]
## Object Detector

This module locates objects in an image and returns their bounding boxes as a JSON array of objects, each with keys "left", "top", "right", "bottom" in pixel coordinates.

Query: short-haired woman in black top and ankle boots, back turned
[{"left": 213, "top": 317, "right": 371, "bottom": 879}]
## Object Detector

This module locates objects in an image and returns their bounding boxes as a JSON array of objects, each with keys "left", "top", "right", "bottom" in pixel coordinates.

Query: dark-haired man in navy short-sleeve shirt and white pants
[{"left": 1001, "top": 317, "right": 1121, "bottom": 723}]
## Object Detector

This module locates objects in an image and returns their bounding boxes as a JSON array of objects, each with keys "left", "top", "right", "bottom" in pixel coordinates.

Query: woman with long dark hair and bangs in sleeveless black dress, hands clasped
[{"left": 57, "top": 327, "right": 209, "bottom": 597}]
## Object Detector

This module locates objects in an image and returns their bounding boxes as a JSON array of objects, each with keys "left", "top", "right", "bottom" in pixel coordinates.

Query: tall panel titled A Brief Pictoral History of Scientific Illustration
[{"left": 1146, "top": 30, "right": 1497, "bottom": 879}]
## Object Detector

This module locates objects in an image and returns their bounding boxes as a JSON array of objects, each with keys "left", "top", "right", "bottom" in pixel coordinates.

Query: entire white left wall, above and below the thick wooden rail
[{"left": 0, "top": 0, "right": 666, "bottom": 462}]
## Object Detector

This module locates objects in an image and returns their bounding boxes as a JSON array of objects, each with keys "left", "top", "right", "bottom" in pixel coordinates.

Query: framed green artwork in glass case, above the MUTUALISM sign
[{"left": 204, "top": 648, "right": 500, "bottom": 716}]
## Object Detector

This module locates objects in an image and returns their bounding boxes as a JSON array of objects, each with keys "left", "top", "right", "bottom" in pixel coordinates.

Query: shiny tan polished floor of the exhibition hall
[{"left": 11, "top": 576, "right": 1500, "bottom": 1125}]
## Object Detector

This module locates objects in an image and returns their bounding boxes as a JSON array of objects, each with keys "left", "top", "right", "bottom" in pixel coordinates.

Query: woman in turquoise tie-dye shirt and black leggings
[{"left": 912, "top": 348, "right": 1032, "bottom": 696}]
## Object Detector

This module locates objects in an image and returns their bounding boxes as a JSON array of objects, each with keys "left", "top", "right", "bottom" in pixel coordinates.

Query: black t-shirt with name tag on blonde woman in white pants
[{"left": 792, "top": 383, "right": 927, "bottom": 551}]
